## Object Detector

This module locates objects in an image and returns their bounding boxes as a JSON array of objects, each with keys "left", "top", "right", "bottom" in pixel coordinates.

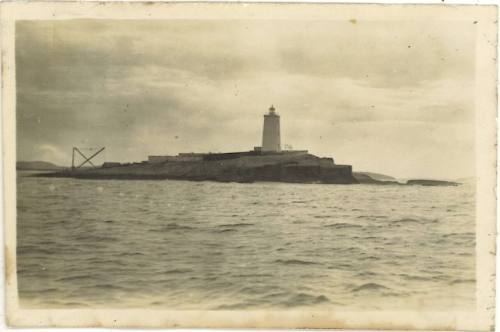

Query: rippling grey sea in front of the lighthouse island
[{"left": 17, "top": 172, "right": 475, "bottom": 310}]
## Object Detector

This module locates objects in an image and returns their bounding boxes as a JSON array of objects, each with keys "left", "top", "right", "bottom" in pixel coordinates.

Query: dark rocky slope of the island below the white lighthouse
[{"left": 40, "top": 154, "right": 358, "bottom": 184}]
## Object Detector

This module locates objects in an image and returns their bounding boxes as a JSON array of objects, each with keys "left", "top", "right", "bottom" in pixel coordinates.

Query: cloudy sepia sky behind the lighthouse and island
[{"left": 16, "top": 20, "right": 475, "bottom": 178}]
